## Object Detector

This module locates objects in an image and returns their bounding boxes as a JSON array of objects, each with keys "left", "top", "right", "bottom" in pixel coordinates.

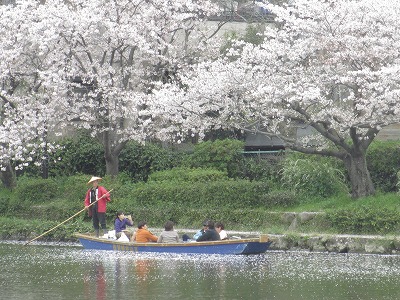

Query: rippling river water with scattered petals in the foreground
[{"left": 0, "top": 241, "right": 400, "bottom": 300}]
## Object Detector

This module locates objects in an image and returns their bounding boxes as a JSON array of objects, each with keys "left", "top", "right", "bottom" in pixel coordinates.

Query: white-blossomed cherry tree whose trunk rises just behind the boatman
[{"left": 0, "top": 0, "right": 223, "bottom": 184}]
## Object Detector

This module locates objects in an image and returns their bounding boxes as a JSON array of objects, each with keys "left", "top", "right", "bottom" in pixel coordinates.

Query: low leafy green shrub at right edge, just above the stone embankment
[{"left": 327, "top": 206, "right": 400, "bottom": 234}]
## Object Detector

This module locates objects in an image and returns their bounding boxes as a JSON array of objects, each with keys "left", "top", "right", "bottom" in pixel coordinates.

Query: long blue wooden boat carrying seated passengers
[{"left": 75, "top": 233, "right": 272, "bottom": 255}]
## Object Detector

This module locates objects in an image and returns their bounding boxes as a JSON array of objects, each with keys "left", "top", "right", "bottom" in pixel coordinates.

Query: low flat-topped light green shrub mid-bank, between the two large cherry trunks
[{"left": 149, "top": 167, "right": 228, "bottom": 182}]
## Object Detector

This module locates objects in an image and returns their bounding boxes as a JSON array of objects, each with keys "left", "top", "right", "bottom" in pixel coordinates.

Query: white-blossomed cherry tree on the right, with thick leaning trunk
[{"left": 155, "top": 0, "right": 400, "bottom": 198}]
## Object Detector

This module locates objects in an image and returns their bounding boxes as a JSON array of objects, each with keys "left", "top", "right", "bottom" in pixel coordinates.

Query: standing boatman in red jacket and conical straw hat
[{"left": 85, "top": 177, "right": 110, "bottom": 237}]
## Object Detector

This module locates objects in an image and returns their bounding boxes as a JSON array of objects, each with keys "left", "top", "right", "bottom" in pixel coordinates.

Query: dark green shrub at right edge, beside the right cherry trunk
[{"left": 367, "top": 141, "right": 400, "bottom": 192}]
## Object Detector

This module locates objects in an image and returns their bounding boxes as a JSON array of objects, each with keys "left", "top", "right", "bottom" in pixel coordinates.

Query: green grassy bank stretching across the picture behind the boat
[{"left": 0, "top": 176, "right": 400, "bottom": 240}]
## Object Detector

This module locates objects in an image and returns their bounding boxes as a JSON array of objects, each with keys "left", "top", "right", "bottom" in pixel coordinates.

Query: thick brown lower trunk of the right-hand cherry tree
[{"left": 344, "top": 152, "right": 375, "bottom": 198}]
